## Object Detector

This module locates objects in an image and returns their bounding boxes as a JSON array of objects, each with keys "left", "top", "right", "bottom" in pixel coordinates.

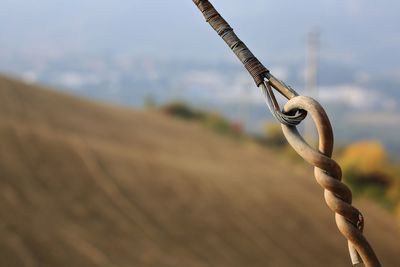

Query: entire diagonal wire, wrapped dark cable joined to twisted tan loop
[{"left": 193, "top": 0, "right": 381, "bottom": 267}]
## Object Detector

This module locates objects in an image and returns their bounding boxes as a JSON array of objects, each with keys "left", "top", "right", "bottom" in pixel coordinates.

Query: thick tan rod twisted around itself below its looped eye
[{"left": 282, "top": 96, "right": 381, "bottom": 267}]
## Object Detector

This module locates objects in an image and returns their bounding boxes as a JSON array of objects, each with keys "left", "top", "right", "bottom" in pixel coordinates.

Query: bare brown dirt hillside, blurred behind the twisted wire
[{"left": 0, "top": 77, "right": 400, "bottom": 267}]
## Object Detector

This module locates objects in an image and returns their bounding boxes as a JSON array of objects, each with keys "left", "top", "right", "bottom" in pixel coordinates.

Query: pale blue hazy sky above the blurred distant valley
[{"left": 0, "top": 0, "right": 400, "bottom": 72}]
